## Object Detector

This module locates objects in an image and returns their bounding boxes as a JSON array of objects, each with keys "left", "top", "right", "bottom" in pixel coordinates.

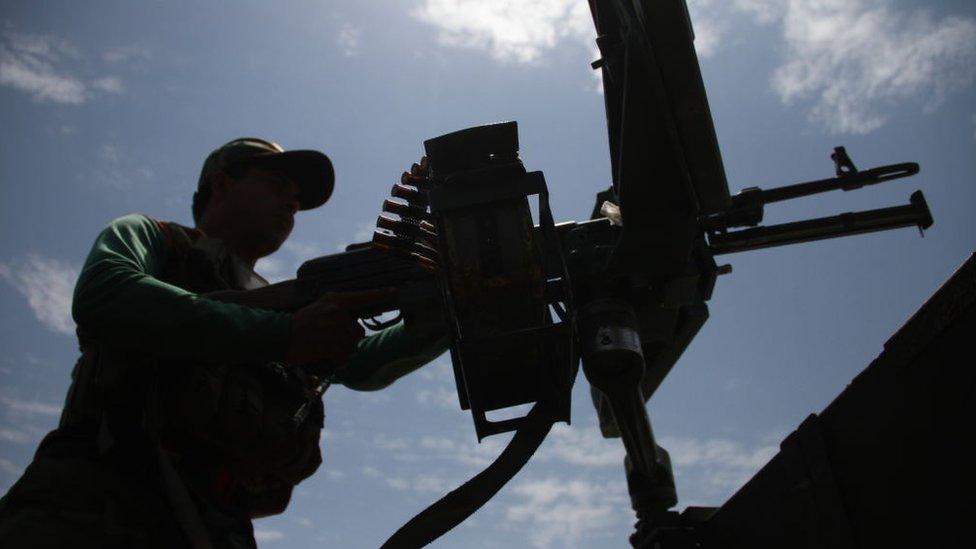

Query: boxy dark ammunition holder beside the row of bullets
[{"left": 424, "top": 122, "right": 576, "bottom": 440}]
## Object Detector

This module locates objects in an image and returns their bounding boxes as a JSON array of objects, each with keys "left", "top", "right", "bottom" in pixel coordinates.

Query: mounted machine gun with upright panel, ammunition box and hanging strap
[{"left": 212, "top": 0, "right": 932, "bottom": 547}]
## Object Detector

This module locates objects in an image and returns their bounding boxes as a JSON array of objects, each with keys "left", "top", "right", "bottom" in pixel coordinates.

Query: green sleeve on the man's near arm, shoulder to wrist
[{"left": 71, "top": 214, "right": 291, "bottom": 362}]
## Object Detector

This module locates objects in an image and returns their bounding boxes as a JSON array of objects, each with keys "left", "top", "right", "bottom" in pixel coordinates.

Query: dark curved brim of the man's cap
[{"left": 251, "top": 150, "right": 335, "bottom": 210}]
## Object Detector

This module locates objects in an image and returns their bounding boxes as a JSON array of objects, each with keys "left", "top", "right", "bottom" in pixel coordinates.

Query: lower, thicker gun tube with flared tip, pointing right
[{"left": 709, "top": 191, "right": 932, "bottom": 255}]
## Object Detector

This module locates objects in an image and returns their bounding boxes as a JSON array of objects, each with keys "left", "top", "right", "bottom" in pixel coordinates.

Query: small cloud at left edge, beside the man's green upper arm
[{"left": 0, "top": 254, "right": 78, "bottom": 335}]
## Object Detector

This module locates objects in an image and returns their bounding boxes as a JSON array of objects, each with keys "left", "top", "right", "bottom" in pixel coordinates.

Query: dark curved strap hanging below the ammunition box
[{"left": 381, "top": 402, "right": 555, "bottom": 549}]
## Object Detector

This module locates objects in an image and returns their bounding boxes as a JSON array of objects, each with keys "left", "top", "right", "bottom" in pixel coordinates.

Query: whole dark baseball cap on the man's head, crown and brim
[{"left": 197, "top": 137, "right": 335, "bottom": 210}]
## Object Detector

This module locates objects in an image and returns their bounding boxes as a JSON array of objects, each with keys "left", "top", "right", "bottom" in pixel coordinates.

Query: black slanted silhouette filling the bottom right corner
[{"left": 635, "top": 255, "right": 976, "bottom": 549}]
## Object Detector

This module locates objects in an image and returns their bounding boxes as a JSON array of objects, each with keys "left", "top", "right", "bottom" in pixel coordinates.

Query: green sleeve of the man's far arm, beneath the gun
[{"left": 335, "top": 322, "right": 448, "bottom": 391}]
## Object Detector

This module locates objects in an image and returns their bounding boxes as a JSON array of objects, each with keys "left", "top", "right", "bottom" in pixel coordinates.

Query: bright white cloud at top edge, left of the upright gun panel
[{"left": 412, "top": 0, "right": 595, "bottom": 63}]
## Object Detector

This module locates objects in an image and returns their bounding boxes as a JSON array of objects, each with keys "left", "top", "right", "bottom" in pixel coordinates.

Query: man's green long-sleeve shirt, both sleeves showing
[{"left": 72, "top": 214, "right": 446, "bottom": 390}]
